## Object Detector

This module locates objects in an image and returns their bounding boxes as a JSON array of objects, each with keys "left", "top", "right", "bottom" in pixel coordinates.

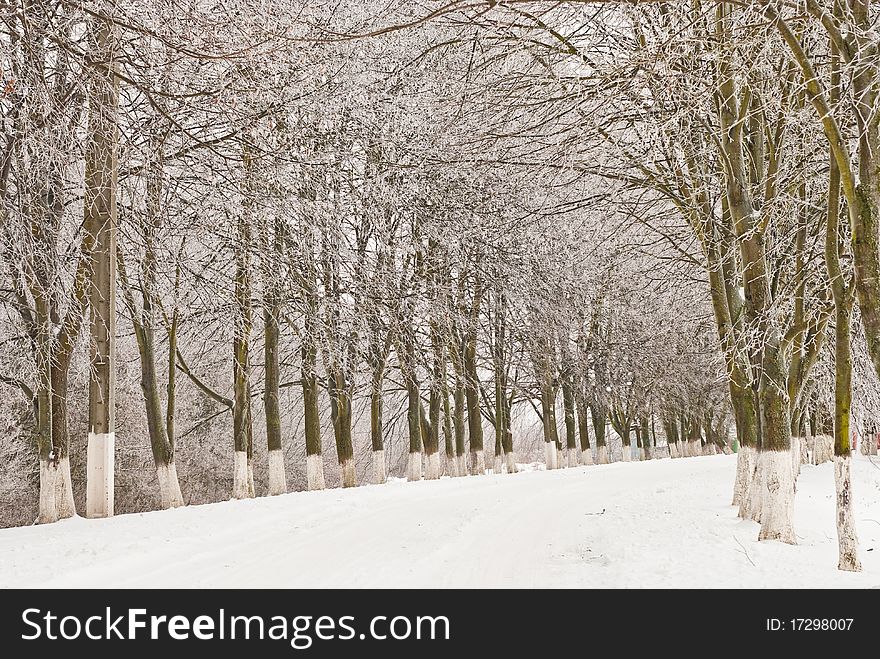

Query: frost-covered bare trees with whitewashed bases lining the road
[{"left": 0, "top": 0, "right": 880, "bottom": 570}]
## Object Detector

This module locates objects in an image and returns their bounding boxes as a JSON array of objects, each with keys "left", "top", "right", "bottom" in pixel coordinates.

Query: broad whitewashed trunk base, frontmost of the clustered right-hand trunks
[{"left": 758, "top": 451, "right": 797, "bottom": 545}]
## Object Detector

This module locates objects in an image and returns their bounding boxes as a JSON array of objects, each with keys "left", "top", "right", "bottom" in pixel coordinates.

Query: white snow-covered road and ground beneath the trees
[{"left": 0, "top": 456, "right": 880, "bottom": 587}]
